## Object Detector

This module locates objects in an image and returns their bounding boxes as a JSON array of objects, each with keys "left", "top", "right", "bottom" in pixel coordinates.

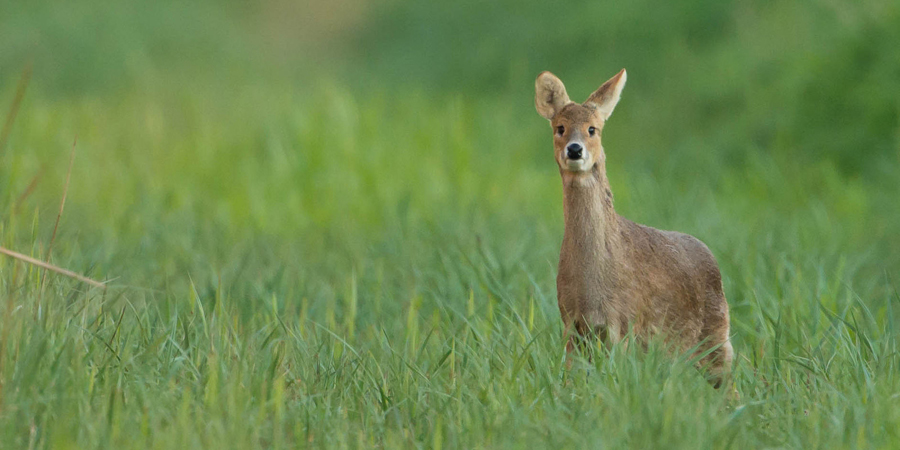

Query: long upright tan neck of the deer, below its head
[{"left": 561, "top": 163, "right": 619, "bottom": 268}]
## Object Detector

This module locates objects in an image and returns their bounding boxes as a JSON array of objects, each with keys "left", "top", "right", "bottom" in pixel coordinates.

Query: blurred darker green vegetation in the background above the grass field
[{"left": 0, "top": 0, "right": 900, "bottom": 176}]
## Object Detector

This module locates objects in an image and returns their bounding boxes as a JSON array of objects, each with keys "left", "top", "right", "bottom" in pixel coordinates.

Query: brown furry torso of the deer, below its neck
[{"left": 558, "top": 217, "right": 728, "bottom": 347}]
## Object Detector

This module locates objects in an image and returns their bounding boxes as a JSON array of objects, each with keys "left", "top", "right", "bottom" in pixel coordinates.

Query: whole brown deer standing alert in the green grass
[{"left": 535, "top": 69, "right": 733, "bottom": 387}]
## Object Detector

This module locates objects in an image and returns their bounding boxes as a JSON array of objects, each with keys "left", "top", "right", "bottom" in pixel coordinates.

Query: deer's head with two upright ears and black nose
[{"left": 534, "top": 69, "right": 626, "bottom": 172}]
